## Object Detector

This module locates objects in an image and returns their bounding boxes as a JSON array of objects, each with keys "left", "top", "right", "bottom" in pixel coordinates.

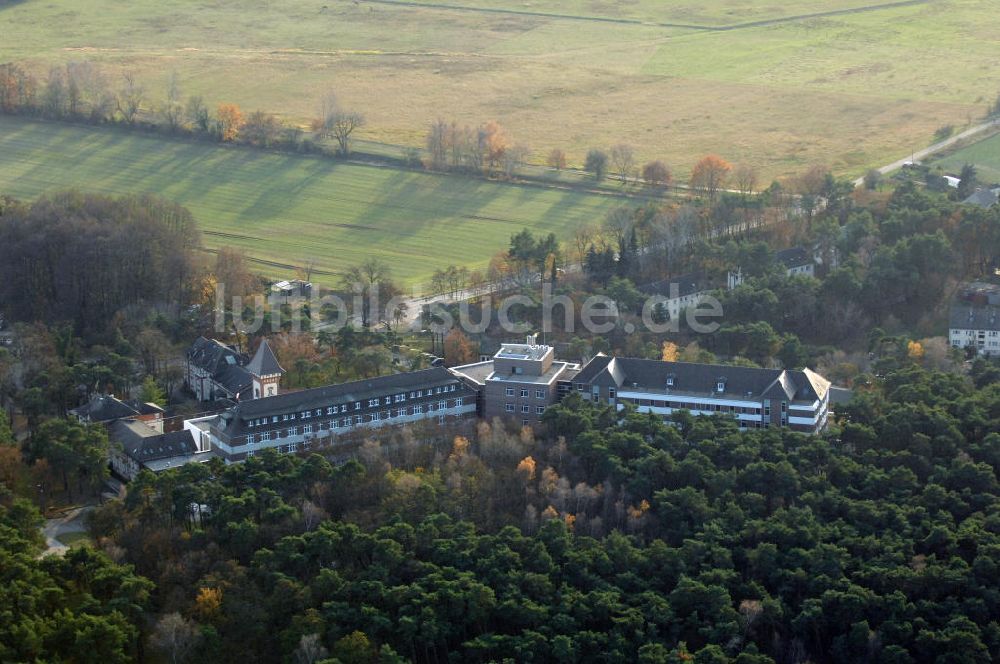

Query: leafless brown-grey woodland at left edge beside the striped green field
[{"left": 0, "top": 192, "right": 200, "bottom": 332}]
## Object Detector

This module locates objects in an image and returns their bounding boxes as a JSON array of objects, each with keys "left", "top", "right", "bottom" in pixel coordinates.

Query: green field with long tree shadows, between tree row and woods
[{"left": 0, "top": 117, "right": 621, "bottom": 287}]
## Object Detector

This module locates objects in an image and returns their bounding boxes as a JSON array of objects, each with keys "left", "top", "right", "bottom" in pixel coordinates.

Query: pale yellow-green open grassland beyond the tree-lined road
[{"left": 0, "top": 0, "right": 1000, "bottom": 182}]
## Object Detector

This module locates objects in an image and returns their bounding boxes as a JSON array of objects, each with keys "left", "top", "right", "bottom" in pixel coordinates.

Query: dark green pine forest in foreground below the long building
[{"left": 0, "top": 350, "right": 1000, "bottom": 663}]
